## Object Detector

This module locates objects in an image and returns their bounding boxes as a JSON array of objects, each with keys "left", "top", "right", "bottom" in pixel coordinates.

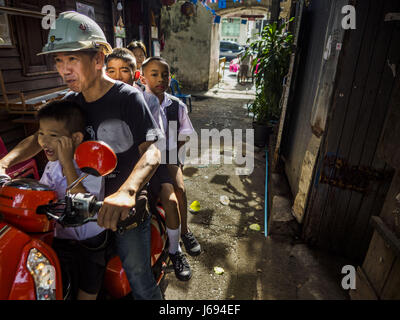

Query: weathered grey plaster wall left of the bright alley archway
[{"left": 161, "top": 1, "right": 219, "bottom": 90}]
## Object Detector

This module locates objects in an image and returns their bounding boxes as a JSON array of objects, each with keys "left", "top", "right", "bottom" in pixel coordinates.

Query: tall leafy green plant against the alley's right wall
[{"left": 245, "top": 18, "right": 293, "bottom": 147}]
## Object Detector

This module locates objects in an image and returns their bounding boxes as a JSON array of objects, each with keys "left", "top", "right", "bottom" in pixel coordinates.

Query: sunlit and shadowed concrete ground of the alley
[{"left": 161, "top": 65, "right": 348, "bottom": 300}]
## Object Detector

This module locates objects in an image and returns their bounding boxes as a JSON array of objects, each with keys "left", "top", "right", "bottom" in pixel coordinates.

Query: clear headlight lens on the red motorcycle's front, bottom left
[{"left": 26, "top": 248, "right": 56, "bottom": 300}]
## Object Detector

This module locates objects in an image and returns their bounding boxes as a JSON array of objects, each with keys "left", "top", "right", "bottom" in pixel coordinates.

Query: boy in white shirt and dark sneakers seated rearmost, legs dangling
[{"left": 141, "top": 57, "right": 201, "bottom": 280}]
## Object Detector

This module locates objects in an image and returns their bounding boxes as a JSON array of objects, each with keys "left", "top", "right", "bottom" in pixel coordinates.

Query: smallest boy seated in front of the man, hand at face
[{"left": 37, "top": 100, "right": 108, "bottom": 300}]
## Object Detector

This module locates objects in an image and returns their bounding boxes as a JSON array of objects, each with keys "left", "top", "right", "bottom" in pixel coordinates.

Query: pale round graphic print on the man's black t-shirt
[{"left": 97, "top": 119, "right": 134, "bottom": 153}]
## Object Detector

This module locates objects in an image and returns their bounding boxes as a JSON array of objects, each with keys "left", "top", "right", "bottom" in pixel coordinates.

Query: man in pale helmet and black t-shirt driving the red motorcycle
[{"left": 0, "top": 11, "right": 163, "bottom": 299}]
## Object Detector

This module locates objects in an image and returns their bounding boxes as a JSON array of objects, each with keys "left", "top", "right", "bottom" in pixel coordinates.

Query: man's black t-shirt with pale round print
[{"left": 65, "top": 81, "right": 163, "bottom": 196}]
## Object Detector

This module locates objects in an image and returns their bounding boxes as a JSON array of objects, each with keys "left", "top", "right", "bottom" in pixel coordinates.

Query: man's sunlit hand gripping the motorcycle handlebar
[{"left": 97, "top": 191, "right": 136, "bottom": 231}]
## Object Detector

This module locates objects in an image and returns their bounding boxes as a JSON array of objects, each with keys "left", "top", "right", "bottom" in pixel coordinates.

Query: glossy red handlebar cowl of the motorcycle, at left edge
[{"left": 0, "top": 186, "right": 57, "bottom": 232}]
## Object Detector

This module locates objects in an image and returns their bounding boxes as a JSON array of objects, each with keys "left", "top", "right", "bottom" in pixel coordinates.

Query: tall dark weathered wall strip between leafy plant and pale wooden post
[{"left": 281, "top": 1, "right": 332, "bottom": 199}]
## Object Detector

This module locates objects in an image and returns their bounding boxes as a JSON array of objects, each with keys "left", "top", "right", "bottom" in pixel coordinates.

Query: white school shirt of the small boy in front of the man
[{"left": 39, "top": 160, "right": 104, "bottom": 240}]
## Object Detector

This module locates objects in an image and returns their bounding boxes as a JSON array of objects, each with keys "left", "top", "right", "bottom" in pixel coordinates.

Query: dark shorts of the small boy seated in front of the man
[{"left": 53, "top": 230, "right": 113, "bottom": 299}]
